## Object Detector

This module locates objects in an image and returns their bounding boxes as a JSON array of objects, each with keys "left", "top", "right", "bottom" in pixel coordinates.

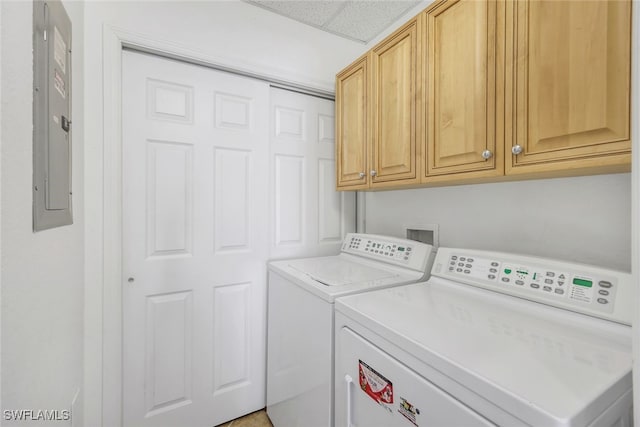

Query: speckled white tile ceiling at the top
[{"left": 244, "top": 0, "right": 421, "bottom": 43}]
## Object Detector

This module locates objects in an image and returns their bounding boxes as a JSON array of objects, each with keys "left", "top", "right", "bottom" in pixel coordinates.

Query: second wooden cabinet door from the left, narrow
[{"left": 369, "top": 18, "right": 419, "bottom": 186}]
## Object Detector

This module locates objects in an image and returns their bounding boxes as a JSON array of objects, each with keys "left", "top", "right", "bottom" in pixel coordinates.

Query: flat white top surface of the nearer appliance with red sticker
[{"left": 336, "top": 278, "right": 631, "bottom": 426}]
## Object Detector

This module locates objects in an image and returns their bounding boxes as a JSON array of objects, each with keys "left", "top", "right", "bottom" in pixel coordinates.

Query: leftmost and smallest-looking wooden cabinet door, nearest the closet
[{"left": 336, "top": 56, "right": 369, "bottom": 190}]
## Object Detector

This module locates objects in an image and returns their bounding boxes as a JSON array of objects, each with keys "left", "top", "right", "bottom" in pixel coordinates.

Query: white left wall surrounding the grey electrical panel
[{"left": 0, "top": 1, "right": 84, "bottom": 426}]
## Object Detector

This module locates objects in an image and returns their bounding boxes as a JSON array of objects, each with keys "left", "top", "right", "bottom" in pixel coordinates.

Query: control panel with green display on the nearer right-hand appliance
[{"left": 432, "top": 248, "right": 630, "bottom": 320}]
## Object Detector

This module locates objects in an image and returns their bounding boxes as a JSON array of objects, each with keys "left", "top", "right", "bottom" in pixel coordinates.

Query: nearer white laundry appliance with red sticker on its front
[{"left": 335, "top": 248, "right": 635, "bottom": 427}]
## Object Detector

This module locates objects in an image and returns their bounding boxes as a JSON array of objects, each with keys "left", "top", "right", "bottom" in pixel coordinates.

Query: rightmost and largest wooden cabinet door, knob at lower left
[{"left": 506, "top": 0, "right": 631, "bottom": 174}]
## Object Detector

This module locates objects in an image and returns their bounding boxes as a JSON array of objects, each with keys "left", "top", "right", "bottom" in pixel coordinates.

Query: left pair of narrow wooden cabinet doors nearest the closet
[{"left": 336, "top": 18, "right": 421, "bottom": 190}]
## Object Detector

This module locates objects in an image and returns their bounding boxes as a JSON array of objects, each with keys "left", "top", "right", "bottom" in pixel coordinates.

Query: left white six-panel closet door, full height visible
[{"left": 121, "top": 52, "right": 269, "bottom": 427}]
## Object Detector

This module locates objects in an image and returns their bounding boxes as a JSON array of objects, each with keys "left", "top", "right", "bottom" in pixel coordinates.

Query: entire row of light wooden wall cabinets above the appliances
[{"left": 336, "top": 0, "right": 631, "bottom": 189}]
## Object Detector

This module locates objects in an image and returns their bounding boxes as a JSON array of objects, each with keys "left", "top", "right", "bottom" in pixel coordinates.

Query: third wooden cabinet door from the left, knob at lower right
[{"left": 424, "top": 0, "right": 504, "bottom": 181}]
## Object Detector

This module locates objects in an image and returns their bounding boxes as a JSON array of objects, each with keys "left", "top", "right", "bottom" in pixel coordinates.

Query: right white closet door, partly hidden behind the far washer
[{"left": 269, "top": 88, "right": 356, "bottom": 258}]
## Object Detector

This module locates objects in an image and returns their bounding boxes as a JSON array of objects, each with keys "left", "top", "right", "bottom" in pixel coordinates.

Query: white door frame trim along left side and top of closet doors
[{"left": 83, "top": 24, "right": 333, "bottom": 426}]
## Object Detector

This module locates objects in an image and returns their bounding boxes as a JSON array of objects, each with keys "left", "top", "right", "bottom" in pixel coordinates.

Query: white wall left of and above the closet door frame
[{"left": 85, "top": 0, "right": 364, "bottom": 426}]
